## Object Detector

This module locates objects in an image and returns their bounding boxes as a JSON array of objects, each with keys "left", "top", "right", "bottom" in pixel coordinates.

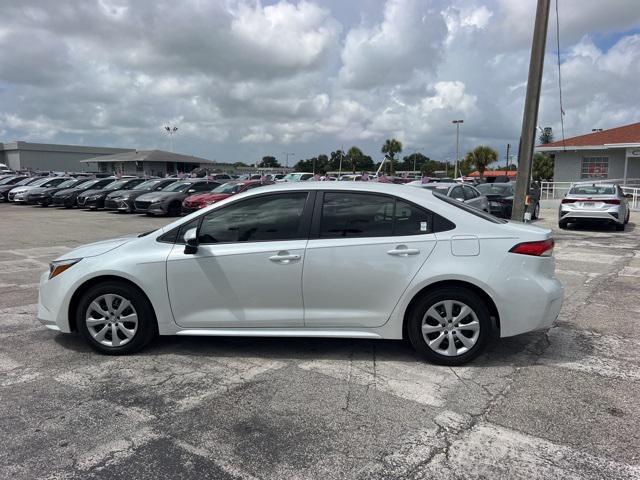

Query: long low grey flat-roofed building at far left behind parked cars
[{"left": 0, "top": 141, "right": 131, "bottom": 172}]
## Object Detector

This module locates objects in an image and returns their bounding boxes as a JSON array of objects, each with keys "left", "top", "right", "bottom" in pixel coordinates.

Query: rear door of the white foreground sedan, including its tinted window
[{"left": 302, "top": 191, "right": 436, "bottom": 327}]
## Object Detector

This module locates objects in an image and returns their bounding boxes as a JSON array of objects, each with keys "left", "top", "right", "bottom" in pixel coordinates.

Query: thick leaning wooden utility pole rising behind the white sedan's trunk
[{"left": 511, "top": 0, "right": 551, "bottom": 221}]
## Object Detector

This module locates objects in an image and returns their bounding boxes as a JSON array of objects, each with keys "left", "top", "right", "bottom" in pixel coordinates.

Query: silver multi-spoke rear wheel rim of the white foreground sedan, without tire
[{"left": 421, "top": 300, "right": 480, "bottom": 357}]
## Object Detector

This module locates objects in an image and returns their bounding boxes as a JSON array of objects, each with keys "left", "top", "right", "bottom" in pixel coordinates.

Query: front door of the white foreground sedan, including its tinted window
[{"left": 167, "top": 192, "right": 310, "bottom": 328}]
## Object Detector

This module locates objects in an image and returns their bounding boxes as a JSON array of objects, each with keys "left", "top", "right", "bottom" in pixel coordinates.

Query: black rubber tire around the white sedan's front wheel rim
[{"left": 76, "top": 281, "right": 158, "bottom": 355}]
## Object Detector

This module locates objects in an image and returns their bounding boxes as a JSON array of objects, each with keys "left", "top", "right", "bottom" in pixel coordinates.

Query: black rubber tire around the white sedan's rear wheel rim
[{"left": 407, "top": 287, "right": 492, "bottom": 366}]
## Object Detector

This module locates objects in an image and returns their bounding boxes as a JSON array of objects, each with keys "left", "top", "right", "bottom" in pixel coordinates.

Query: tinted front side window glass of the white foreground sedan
[{"left": 198, "top": 192, "right": 307, "bottom": 243}]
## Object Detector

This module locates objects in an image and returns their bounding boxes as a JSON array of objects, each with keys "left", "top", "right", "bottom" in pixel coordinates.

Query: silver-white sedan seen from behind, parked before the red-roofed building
[{"left": 558, "top": 183, "right": 629, "bottom": 231}]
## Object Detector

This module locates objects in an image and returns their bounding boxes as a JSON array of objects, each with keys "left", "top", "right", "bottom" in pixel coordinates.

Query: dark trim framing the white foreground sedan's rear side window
[{"left": 309, "top": 190, "right": 457, "bottom": 240}]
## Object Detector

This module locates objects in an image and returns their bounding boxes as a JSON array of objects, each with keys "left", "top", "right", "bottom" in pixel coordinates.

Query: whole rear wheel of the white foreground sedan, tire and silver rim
[{"left": 407, "top": 288, "right": 491, "bottom": 366}]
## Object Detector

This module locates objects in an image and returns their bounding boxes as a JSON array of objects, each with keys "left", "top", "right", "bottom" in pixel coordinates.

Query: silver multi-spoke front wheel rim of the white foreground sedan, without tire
[{"left": 85, "top": 294, "right": 138, "bottom": 347}]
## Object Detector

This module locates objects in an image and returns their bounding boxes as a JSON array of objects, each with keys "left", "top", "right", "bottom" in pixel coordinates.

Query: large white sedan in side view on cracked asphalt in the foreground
[{"left": 38, "top": 182, "right": 563, "bottom": 365}]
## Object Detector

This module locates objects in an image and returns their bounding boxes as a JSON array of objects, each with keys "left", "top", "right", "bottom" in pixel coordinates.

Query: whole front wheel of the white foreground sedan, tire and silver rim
[{"left": 76, "top": 282, "right": 157, "bottom": 355}]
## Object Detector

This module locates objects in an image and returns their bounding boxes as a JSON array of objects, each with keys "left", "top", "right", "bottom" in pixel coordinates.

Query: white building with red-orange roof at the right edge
[{"left": 536, "top": 123, "right": 640, "bottom": 184}]
